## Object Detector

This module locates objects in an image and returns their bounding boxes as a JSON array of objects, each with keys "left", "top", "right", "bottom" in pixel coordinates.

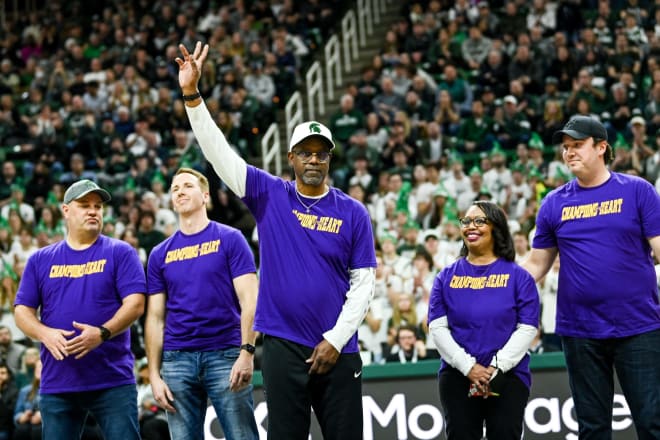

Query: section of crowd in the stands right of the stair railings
[{"left": 336, "top": 0, "right": 660, "bottom": 362}]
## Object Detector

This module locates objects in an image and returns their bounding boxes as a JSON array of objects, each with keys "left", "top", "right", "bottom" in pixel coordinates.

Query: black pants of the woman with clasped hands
[{"left": 439, "top": 368, "right": 529, "bottom": 440}]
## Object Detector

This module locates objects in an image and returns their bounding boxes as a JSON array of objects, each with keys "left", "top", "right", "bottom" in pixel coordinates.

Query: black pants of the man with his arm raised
[{"left": 262, "top": 335, "right": 362, "bottom": 440}]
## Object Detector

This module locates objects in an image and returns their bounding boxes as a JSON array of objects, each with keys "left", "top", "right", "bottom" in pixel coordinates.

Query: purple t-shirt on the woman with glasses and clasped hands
[{"left": 428, "top": 258, "right": 540, "bottom": 387}]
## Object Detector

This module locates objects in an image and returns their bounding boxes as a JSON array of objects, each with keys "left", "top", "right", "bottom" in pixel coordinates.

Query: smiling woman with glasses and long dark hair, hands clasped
[{"left": 428, "top": 201, "right": 539, "bottom": 440}]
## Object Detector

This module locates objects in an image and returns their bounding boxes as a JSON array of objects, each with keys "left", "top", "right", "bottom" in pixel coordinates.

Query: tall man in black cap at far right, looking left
[{"left": 522, "top": 116, "right": 660, "bottom": 440}]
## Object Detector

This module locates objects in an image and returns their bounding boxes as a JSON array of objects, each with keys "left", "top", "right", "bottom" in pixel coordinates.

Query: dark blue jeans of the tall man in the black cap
[{"left": 562, "top": 330, "right": 660, "bottom": 440}]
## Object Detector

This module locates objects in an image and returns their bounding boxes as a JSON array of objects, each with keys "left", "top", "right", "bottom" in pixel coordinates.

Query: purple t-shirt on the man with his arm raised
[{"left": 243, "top": 166, "right": 376, "bottom": 353}]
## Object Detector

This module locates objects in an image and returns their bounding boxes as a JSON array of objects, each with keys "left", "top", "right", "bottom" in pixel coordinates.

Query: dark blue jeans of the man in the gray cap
[{"left": 40, "top": 385, "right": 140, "bottom": 440}]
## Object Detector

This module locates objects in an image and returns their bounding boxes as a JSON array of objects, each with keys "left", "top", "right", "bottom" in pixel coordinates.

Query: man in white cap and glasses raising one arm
[{"left": 177, "top": 43, "right": 376, "bottom": 440}]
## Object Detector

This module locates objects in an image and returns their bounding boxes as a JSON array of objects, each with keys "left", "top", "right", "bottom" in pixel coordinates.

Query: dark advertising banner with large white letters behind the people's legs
[{"left": 205, "top": 354, "right": 636, "bottom": 440}]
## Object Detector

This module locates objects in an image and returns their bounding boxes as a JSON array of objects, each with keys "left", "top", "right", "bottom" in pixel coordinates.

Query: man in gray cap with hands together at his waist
[{"left": 14, "top": 180, "right": 146, "bottom": 440}]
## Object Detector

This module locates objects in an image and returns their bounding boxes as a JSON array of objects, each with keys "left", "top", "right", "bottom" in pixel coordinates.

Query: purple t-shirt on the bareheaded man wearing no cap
[{"left": 147, "top": 221, "right": 256, "bottom": 351}]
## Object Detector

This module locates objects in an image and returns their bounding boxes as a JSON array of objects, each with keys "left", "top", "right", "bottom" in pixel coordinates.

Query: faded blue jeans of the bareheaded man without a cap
[{"left": 161, "top": 348, "right": 259, "bottom": 440}]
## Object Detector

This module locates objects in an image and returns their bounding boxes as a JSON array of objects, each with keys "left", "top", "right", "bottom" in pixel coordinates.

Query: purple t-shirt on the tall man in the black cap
[{"left": 533, "top": 173, "right": 660, "bottom": 339}]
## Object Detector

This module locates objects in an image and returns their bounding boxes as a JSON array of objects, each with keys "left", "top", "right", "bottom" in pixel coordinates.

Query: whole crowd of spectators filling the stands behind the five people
[{"left": 0, "top": 0, "right": 660, "bottom": 434}]
